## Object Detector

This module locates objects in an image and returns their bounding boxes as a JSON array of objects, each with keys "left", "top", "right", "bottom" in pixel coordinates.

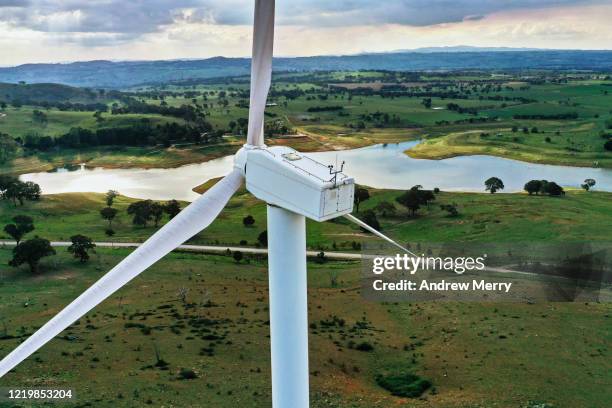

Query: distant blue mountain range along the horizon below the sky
[{"left": 0, "top": 46, "right": 612, "bottom": 88}]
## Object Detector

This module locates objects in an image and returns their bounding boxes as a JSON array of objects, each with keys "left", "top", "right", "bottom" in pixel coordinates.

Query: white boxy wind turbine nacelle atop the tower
[{"left": 237, "top": 146, "right": 355, "bottom": 221}]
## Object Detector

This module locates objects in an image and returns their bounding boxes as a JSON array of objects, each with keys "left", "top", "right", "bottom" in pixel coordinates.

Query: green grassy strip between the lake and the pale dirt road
[{"left": 0, "top": 190, "right": 612, "bottom": 250}]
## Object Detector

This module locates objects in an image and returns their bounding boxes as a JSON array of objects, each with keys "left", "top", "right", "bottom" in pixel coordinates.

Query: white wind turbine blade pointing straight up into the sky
[{"left": 247, "top": 0, "right": 274, "bottom": 146}]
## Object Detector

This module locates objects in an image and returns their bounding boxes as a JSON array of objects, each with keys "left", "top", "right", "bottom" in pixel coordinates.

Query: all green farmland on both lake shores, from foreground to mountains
[{"left": 0, "top": 71, "right": 612, "bottom": 408}]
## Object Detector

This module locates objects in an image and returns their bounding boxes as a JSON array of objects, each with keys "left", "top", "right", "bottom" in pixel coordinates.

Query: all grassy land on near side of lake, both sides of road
[{"left": 0, "top": 186, "right": 612, "bottom": 408}]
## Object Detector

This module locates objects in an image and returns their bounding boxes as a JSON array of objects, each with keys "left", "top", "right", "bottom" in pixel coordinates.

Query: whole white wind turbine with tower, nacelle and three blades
[{"left": 0, "top": 0, "right": 405, "bottom": 408}]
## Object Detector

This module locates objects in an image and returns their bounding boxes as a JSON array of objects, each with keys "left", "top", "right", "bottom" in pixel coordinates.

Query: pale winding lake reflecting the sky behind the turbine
[{"left": 20, "top": 141, "right": 612, "bottom": 201}]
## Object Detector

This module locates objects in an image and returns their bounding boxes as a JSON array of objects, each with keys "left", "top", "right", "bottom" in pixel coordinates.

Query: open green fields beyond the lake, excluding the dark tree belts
[{"left": 0, "top": 72, "right": 612, "bottom": 173}]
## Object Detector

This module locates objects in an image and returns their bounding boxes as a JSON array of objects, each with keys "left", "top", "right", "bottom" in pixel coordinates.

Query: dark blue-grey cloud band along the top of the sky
[{"left": 0, "top": 0, "right": 608, "bottom": 42}]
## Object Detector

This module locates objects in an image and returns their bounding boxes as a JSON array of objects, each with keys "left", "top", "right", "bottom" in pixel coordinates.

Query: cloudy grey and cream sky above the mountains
[{"left": 0, "top": 0, "right": 612, "bottom": 66}]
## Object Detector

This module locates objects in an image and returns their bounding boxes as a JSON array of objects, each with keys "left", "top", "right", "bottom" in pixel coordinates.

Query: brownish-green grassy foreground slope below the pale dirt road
[{"left": 0, "top": 249, "right": 612, "bottom": 407}]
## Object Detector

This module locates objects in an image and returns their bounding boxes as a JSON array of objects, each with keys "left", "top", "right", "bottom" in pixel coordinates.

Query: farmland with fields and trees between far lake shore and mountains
[{"left": 0, "top": 71, "right": 612, "bottom": 173}]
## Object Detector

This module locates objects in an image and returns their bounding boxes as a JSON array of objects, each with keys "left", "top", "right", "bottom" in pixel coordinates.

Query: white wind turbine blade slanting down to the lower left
[{"left": 0, "top": 170, "right": 243, "bottom": 377}]
